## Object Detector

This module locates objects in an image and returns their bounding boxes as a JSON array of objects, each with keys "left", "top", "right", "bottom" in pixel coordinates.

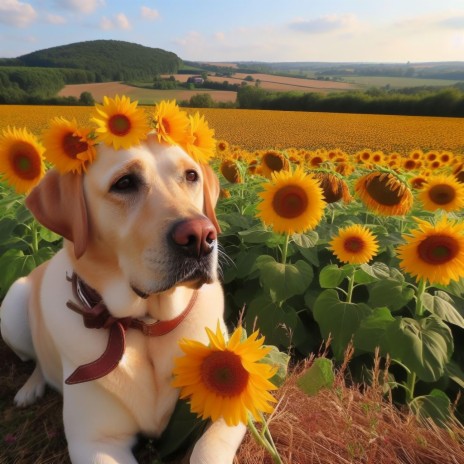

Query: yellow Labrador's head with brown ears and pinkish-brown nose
[{"left": 26, "top": 136, "right": 219, "bottom": 297}]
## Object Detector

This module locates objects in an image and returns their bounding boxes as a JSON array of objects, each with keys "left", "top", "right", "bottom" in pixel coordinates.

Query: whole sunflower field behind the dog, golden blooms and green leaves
[{"left": 0, "top": 103, "right": 464, "bottom": 434}]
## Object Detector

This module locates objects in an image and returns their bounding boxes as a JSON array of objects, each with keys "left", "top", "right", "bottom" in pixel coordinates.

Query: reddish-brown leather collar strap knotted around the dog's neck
[{"left": 65, "top": 273, "right": 198, "bottom": 385}]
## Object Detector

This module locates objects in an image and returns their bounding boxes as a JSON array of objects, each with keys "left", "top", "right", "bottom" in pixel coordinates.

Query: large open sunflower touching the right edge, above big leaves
[{"left": 396, "top": 216, "right": 464, "bottom": 285}]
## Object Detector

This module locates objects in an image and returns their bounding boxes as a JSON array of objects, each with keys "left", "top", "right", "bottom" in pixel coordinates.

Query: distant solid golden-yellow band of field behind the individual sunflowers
[{"left": 0, "top": 105, "right": 464, "bottom": 153}]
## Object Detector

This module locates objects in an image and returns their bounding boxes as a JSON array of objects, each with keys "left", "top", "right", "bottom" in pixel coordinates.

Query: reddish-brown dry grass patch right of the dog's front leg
[{"left": 236, "top": 358, "right": 464, "bottom": 464}]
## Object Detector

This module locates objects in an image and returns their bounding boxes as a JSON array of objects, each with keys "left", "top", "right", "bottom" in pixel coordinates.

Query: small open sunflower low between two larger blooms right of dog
[{"left": 329, "top": 224, "right": 379, "bottom": 264}]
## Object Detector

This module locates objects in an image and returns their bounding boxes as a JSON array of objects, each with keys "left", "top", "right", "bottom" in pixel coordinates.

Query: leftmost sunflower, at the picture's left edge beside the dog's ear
[{"left": 0, "top": 127, "right": 45, "bottom": 193}]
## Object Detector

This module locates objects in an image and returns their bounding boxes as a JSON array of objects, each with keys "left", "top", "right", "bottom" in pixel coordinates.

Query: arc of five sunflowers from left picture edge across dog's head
[{"left": 0, "top": 96, "right": 216, "bottom": 193}]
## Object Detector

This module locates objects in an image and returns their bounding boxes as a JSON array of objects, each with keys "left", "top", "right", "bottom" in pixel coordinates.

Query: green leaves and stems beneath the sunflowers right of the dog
[{"left": 218, "top": 159, "right": 464, "bottom": 423}]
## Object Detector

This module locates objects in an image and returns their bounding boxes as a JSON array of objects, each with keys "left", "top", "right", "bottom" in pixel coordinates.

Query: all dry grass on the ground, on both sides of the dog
[{"left": 0, "top": 341, "right": 464, "bottom": 464}]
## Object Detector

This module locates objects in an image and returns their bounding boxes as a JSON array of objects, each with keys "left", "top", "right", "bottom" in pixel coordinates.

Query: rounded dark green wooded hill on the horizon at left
[{"left": 9, "top": 40, "right": 182, "bottom": 82}]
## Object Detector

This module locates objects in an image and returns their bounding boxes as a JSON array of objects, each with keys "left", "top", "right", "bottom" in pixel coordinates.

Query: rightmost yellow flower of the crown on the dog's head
[{"left": 183, "top": 112, "right": 216, "bottom": 164}]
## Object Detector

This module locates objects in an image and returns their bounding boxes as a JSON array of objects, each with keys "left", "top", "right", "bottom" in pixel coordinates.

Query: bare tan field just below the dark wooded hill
[{"left": 58, "top": 82, "right": 237, "bottom": 105}]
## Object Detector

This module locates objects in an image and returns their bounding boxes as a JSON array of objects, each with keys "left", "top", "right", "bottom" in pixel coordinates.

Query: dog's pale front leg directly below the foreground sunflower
[{"left": 190, "top": 419, "right": 246, "bottom": 464}]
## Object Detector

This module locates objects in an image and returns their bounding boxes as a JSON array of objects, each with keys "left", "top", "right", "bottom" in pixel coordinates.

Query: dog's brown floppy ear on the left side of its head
[{"left": 26, "top": 169, "right": 89, "bottom": 259}]
